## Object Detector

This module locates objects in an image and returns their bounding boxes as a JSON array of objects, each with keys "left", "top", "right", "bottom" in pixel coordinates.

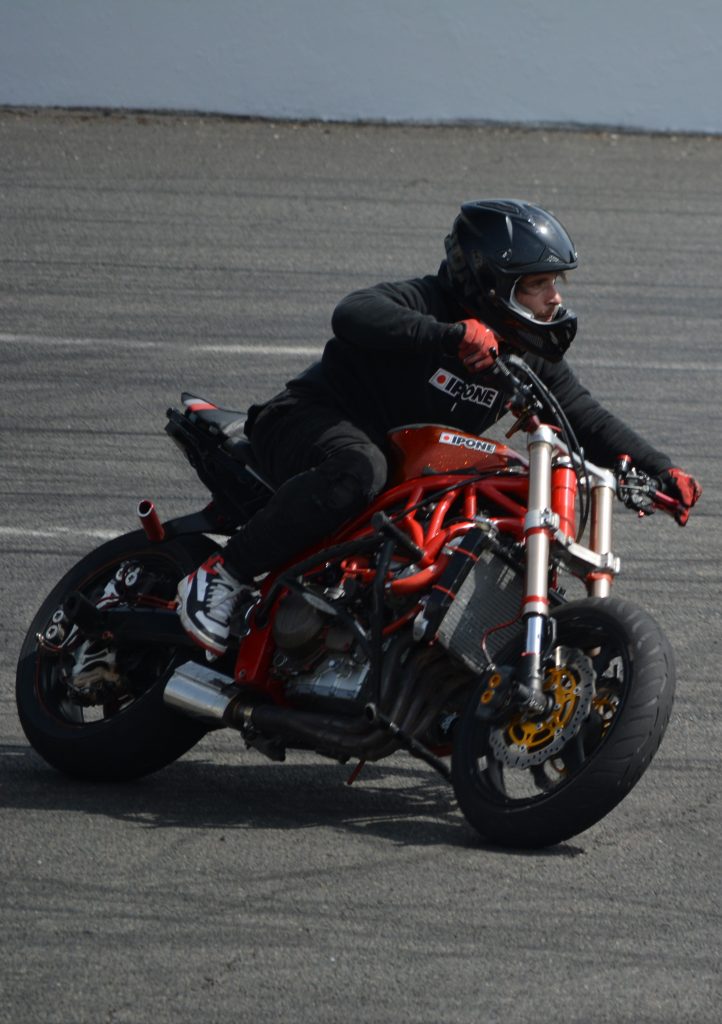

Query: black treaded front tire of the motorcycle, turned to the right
[{"left": 452, "top": 598, "right": 675, "bottom": 848}]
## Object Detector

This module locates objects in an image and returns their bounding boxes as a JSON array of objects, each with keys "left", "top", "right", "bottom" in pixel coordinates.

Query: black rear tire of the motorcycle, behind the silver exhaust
[{"left": 15, "top": 530, "right": 213, "bottom": 781}]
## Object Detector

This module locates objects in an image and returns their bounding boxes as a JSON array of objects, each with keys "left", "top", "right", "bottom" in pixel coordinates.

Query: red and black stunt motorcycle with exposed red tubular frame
[{"left": 16, "top": 356, "right": 681, "bottom": 848}]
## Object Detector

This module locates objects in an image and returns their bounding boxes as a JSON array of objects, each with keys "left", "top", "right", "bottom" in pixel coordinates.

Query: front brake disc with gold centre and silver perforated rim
[{"left": 490, "top": 647, "right": 595, "bottom": 768}]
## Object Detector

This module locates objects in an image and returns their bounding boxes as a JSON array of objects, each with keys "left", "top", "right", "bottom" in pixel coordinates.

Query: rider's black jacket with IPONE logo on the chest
[{"left": 289, "top": 264, "right": 672, "bottom": 474}]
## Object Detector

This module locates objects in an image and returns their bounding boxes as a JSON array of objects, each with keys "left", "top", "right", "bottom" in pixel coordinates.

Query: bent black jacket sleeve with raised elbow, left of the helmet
[{"left": 331, "top": 279, "right": 463, "bottom": 355}]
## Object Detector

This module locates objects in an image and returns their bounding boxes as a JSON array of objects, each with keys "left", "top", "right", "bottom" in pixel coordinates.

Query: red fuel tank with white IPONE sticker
[{"left": 388, "top": 423, "right": 527, "bottom": 484}]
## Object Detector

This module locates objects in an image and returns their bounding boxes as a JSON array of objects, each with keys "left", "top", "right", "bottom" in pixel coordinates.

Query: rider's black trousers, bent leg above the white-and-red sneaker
[{"left": 225, "top": 391, "right": 387, "bottom": 581}]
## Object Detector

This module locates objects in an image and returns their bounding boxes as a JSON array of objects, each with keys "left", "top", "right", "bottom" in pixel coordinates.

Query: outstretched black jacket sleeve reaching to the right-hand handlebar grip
[{"left": 529, "top": 359, "right": 672, "bottom": 476}]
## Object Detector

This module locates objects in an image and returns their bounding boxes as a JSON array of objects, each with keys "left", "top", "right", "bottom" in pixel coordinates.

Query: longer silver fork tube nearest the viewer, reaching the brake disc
[{"left": 521, "top": 427, "right": 554, "bottom": 709}]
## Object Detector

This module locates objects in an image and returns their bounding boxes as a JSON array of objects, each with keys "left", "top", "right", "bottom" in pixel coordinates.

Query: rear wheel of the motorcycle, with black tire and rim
[{"left": 15, "top": 530, "right": 213, "bottom": 780}]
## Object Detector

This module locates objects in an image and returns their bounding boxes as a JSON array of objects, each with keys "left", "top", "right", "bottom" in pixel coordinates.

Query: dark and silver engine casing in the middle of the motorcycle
[{"left": 273, "top": 591, "right": 369, "bottom": 714}]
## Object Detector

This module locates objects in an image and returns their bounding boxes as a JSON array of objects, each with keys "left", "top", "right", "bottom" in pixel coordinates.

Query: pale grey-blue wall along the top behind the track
[{"left": 0, "top": 0, "right": 722, "bottom": 133}]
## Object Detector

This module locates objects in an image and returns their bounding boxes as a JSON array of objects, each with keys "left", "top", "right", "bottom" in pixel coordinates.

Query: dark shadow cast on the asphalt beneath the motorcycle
[{"left": 0, "top": 744, "right": 584, "bottom": 857}]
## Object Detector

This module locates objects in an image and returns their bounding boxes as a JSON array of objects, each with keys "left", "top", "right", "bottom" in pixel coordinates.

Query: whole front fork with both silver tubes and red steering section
[{"left": 518, "top": 426, "right": 614, "bottom": 714}]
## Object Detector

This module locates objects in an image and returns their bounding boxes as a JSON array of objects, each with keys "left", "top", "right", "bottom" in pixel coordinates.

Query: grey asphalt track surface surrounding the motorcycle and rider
[{"left": 0, "top": 112, "right": 722, "bottom": 1024}]
